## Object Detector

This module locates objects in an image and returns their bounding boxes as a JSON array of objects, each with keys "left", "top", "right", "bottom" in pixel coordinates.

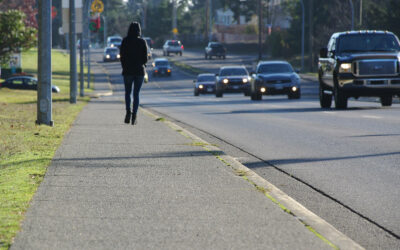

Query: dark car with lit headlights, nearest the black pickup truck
[{"left": 250, "top": 61, "right": 301, "bottom": 101}]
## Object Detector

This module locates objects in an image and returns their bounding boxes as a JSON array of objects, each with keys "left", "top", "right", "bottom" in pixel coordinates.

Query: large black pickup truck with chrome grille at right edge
[{"left": 318, "top": 31, "right": 400, "bottom": 109}]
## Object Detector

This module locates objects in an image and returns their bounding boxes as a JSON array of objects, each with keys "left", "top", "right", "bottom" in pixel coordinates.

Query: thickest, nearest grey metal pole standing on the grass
[{"left": 36, "top": 0, "right": 54, "bottom": 126}]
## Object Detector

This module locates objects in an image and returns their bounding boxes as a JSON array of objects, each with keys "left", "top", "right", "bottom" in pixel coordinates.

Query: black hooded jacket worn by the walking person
[{"left": 120, "top": 23, "right": 147, "bottom": 76}]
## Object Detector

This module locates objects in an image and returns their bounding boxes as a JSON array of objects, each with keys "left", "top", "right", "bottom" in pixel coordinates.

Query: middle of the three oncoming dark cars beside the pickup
[{"left": 215, "top": 66, "right": 250, "bottom": 97}]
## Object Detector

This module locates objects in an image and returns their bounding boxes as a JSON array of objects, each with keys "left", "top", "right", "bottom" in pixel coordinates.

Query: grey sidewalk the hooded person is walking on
[{"left": 12, "top": 63, "right": 350, "bottom": 249}]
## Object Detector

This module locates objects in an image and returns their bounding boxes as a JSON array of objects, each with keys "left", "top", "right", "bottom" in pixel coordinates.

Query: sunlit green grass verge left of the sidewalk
[{"left": 0, "top": 50, "right": 90, "bottom": 249}]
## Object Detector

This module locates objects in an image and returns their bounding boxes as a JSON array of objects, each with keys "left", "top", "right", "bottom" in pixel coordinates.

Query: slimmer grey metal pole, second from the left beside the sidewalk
[{"left": 69, "top": 0, "right": 77, "bottom": 103}]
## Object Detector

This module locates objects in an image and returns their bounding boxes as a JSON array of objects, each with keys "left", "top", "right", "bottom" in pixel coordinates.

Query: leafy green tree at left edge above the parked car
[{"left": 0, "top": 10, "right": 37, "bottom": 63}]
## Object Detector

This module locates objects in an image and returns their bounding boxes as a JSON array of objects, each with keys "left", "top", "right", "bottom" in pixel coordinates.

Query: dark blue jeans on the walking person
[{"left": 124, "top": 75, "right": 144, "bottom": 114}]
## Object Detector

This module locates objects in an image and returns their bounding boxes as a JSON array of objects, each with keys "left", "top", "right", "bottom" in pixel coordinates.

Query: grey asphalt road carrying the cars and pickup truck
[{"left": 95, "top": 47, "right": 400, "bottom": 249}]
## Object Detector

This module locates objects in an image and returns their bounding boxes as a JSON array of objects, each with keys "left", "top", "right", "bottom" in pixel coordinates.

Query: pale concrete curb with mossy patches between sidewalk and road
[{"left": 140, "top": 107, "right": 364, "bottom": 249}]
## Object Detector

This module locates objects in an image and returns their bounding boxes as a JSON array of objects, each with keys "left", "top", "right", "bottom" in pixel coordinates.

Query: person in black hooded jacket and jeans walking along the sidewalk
[{"left": 120, "top": 22, "right": 147, "bottom": 125}]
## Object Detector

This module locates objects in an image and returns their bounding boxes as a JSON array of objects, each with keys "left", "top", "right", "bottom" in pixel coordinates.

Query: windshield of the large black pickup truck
[{"left": 337, "top": 34, "right": 400, "bottom": 53}]
